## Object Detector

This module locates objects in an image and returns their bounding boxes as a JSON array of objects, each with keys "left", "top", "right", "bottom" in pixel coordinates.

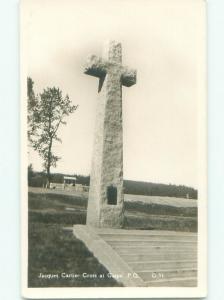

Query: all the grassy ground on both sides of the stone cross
[{"left": 28, "top": 192, "right": 197, "bottom": 287}]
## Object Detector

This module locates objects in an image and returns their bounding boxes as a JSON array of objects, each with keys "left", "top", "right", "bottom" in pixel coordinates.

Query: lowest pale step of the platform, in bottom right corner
[{"left": 146, "top": 277, "right": 197, "bottom": 287}]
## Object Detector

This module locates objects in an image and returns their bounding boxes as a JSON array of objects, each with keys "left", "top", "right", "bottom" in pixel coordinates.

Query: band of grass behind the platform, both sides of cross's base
[{"left": 29, "top": 193, "right": 197, "bottom": 231}]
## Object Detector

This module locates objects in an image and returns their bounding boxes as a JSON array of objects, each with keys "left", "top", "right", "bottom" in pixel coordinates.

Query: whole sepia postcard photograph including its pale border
[{"left": 20, "top": 0, "right": 207, "bottom": 298}]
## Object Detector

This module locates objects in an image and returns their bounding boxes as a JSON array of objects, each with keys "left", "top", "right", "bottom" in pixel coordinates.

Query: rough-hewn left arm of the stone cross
[{"left": 84, "top": 55, "right": 106, "bottom": 78}]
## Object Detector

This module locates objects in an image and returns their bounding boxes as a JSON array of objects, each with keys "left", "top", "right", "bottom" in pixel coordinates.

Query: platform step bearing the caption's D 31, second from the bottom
[{"left": 137, "top": 269, "right": 197, "bottom": 281}]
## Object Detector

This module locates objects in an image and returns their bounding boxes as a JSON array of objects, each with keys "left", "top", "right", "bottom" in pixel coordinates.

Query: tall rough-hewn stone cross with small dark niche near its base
[{"left": 84, "top": 41, "right": 136, "bottom": 228}]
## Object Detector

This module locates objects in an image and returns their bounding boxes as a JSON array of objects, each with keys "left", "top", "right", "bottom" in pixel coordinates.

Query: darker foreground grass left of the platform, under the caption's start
[{"left": 28, "top": 222, "right": 122, "bottom": 287}]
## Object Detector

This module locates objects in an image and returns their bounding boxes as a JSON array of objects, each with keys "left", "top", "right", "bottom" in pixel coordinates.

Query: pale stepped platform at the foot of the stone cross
[{"left": 73, "top": 225, "right": 197, "bottom": 287}]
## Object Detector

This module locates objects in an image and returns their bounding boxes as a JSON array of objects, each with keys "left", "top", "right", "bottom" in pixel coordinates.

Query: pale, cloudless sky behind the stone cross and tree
[{"left": 23, "top": 0, "right": 205, "bottom": 188}]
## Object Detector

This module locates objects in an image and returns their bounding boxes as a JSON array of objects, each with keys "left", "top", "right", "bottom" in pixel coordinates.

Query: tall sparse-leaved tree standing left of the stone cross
[{"left": 27, "top": 78, "right": 78, "bottom": 187}]
